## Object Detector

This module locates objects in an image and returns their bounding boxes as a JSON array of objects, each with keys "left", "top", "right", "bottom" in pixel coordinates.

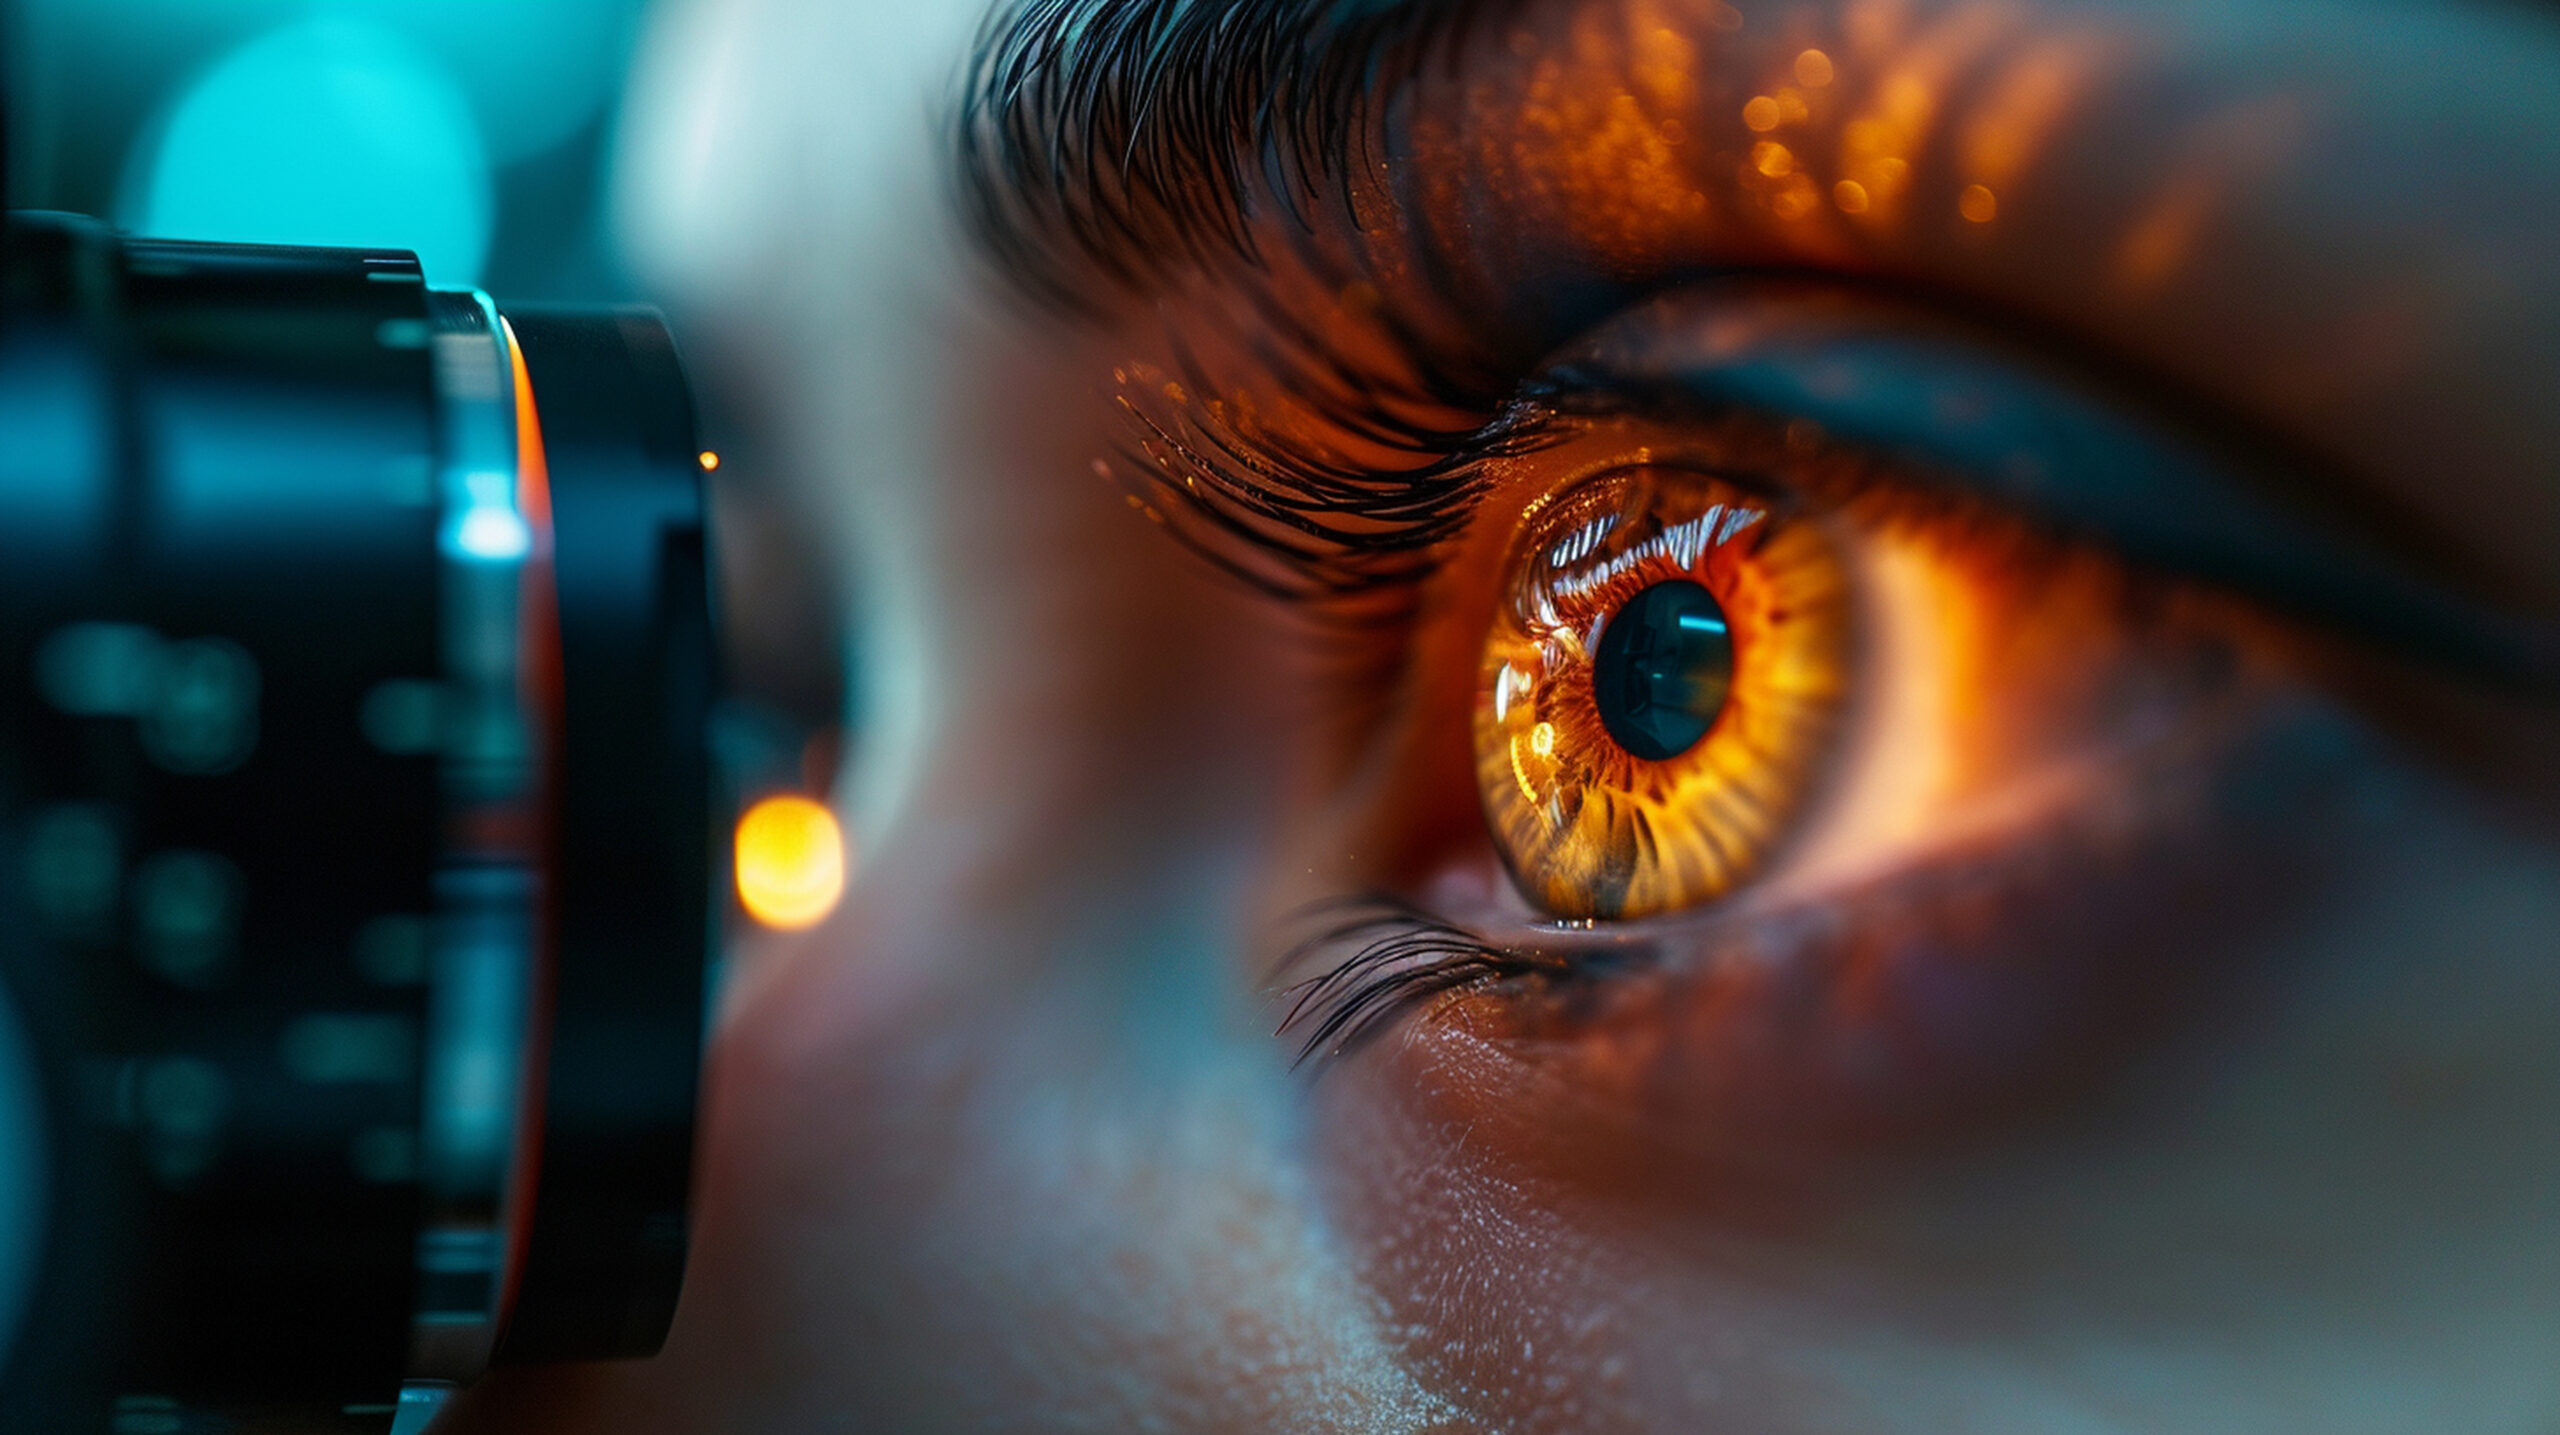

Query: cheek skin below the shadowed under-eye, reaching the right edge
[{"left": 1318, "top": 752, "right": 2560, "bottom": 1435}]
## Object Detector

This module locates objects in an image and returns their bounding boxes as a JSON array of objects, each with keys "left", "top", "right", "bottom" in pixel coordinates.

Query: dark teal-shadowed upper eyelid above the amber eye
[{"left": 1531, "top": 279, "right": 2560, "bottom": 693}]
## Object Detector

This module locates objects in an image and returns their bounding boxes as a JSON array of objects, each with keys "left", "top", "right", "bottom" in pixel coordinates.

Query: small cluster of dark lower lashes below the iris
[{"left": 1272, "top": 893, "right": 1580, "bottom": 1069}]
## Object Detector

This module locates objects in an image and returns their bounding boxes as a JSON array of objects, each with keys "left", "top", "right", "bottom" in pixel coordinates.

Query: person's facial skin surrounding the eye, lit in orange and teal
[{"left": 451, "top": 0, "right": 2560, "bottom": 1435}]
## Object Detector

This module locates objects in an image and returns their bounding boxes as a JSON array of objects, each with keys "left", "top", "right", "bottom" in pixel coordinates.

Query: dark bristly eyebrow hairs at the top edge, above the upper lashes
[{"left": 955, "top": 0, "right": 1508, "bottom": 312}]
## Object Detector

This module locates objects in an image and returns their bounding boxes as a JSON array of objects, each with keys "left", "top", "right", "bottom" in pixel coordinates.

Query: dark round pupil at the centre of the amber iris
[{"left": 1592, "top": 578, "right": 1733, "bottom": 762}]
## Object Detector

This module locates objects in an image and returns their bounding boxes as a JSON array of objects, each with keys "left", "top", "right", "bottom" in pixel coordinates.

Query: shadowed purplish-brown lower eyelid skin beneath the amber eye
[{"left": 1416, "top": 696, "right": 2394, "bottom": 1177}]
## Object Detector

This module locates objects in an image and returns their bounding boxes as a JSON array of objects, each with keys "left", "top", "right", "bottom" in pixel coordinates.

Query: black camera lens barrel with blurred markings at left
[{"left": 0, "top": 215, "right": 724, "bottom": 1432}]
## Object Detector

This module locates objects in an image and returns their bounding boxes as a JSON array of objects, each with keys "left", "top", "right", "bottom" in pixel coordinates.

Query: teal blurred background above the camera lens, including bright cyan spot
[{"left": 0, "top": 0, "right": 648, "bottom": 302}]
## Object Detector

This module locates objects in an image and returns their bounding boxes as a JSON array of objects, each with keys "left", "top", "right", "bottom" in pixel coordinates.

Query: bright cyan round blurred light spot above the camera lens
[{"left": 118, "top": 18, "right": 494, "bottom": 284}]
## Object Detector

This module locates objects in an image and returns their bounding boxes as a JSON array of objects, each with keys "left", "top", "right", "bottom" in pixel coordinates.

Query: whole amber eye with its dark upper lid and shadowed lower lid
[{"left": 1259, "top": 281, "right": 2550, "bottom": 1159}]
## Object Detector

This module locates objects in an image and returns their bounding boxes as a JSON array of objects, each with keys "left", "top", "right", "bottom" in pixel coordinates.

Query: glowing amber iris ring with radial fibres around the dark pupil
[{"left": 1475, "top": 466, "right": 1848, "bottom": 918}]
